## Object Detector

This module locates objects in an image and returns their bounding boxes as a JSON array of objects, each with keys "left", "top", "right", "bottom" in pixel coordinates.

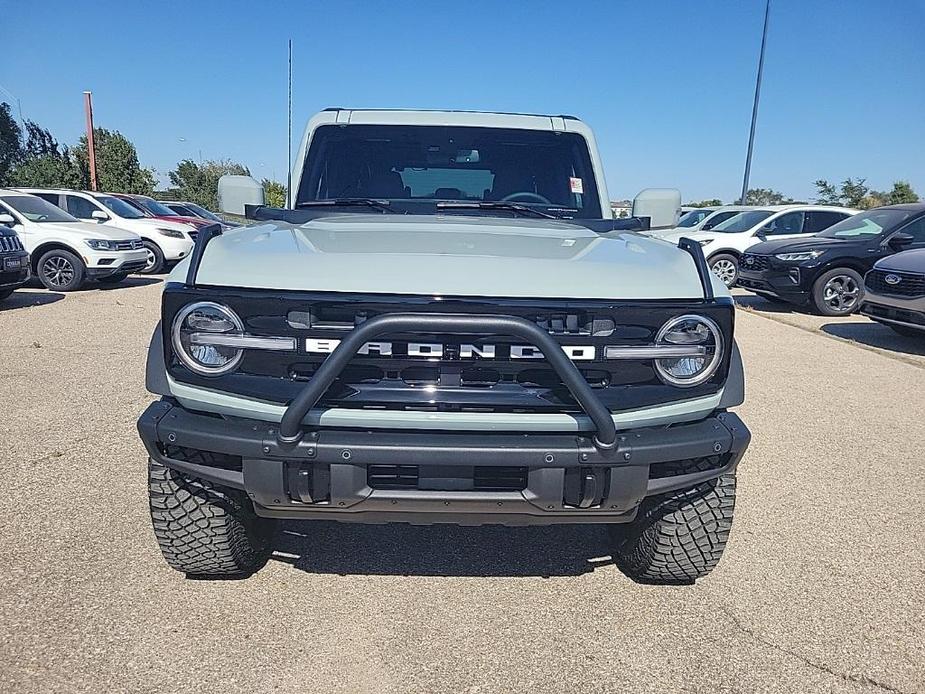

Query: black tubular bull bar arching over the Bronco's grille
[{"left": 277, "top": 313, "right": 617, "bottom": 450}]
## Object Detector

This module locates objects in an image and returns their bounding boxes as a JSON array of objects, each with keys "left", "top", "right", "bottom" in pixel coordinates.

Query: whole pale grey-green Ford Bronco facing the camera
[{"left": 138, "top": 109, "right": 749, "bottom": 583}]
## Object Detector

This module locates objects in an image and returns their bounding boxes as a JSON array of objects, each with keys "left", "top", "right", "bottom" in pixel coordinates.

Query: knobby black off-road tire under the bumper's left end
[{"left": 148, "top": 460, "right": 276, "bottom": 578}]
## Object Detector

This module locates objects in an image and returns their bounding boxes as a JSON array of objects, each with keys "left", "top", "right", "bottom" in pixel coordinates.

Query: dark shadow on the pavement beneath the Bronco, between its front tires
[{"left": 273, "top": 521, "right": 613, "bottom": 577}]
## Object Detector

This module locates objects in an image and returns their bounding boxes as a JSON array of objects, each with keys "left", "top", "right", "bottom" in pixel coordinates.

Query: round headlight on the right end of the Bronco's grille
[{"left": 655, "top": 315, "right": 723, "bottom": 388}]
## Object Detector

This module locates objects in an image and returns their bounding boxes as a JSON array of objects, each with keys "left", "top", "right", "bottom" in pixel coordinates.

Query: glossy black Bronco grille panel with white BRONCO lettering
[{"left": 163, "top": 284, "right": 733, "bottom": 413}]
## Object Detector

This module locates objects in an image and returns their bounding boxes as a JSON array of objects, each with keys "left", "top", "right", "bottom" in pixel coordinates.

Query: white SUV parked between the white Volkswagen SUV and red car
[{"left": 20, "top": 188, "right": 194, "bottom": 274}]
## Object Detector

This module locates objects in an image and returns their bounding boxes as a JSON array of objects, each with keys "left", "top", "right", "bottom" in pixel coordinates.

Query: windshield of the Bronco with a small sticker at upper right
[{"left": 296, "top": 125, "right": 601, "bottom": 219}]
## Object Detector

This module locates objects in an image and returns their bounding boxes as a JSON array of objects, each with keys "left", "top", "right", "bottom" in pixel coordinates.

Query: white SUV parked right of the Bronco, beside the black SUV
[{"left": 659, "top": 205, "right": 858, "bottom": 287}]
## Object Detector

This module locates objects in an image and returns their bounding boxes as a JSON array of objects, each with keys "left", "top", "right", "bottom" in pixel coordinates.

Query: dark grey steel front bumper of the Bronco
[{"left": 138, "top": 399, "right": 750, "bottom": 525}]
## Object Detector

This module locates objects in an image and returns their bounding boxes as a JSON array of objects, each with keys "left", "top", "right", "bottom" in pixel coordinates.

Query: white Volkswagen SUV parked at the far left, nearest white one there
[{"left": 0, "top": 189, "right": 147, "bottom": 292}]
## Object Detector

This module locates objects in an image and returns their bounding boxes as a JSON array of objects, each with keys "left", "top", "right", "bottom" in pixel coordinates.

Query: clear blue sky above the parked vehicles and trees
[{"left": 0, "top": 0, "right": 925, "bottom": 201}]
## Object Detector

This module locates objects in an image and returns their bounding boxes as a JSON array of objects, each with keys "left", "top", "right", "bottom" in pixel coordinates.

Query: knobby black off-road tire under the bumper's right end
[{"left": 611, "top": 470, "right": 736, "bottom": 584}]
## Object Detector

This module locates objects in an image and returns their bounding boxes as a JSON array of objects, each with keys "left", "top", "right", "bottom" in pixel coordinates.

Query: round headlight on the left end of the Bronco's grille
[{"left": 171, "top": 301, "right": 244, "bottom": 376}]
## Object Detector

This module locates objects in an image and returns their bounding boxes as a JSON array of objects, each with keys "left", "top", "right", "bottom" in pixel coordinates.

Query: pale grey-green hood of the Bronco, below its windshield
[{"left": 171, "top": 214, "right": 726, "bottom": 299}]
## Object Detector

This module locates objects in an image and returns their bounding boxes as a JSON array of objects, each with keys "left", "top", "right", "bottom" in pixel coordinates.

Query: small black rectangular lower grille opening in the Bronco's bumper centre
[{"left": 366, "top": 465, "right": 527, "bottom": 492}]
